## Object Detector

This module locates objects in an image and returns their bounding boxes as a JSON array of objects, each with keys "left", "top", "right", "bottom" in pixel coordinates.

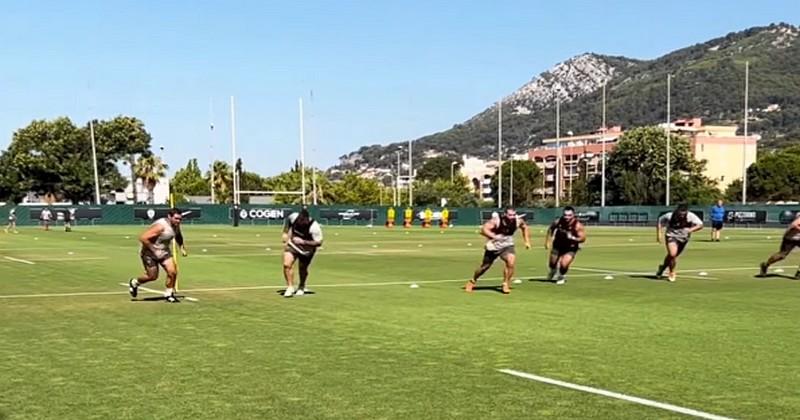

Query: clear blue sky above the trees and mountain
[{"left": 0, "top": 0, "right": 800, "bottom": 175}]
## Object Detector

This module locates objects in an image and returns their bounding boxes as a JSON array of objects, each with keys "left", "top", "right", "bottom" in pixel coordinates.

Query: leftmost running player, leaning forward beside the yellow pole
[{"left": 128, "top": 209, "right": 188, "bottom": 303}]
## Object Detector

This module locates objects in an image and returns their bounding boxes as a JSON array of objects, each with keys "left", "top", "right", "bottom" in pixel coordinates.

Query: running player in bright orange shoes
[{"left": 464, "top": 208, "right": 531, "bottom": 294}]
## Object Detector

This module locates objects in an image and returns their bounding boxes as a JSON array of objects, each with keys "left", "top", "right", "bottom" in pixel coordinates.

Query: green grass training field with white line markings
[{"left": 0, "top": 225, "right": 800, "bottom": 420}]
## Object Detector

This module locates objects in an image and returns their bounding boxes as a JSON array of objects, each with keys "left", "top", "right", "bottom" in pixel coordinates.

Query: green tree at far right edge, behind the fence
[{"left": 726, "top": 146, "right": 800, "bottom": 201}]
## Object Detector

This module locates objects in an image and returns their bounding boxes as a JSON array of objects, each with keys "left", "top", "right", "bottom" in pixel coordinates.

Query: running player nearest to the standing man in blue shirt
[{"left": 656, "top": 204, "right": 703, "bottom": 282}]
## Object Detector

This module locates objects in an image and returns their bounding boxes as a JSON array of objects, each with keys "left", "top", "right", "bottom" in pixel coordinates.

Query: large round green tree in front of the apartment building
[{"left": 608, "top": 127, "right": 719, "bottom": 205}]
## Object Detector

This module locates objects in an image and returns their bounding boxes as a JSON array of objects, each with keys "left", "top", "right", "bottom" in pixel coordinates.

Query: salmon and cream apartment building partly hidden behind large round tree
[{"left": 528, "top": 118, "right": 761, "bottom": 199}]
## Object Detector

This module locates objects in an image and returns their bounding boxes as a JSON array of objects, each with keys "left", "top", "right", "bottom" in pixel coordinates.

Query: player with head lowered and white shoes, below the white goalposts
[{"left": 283, "top": 208, "right": 322, "bottom": 297}]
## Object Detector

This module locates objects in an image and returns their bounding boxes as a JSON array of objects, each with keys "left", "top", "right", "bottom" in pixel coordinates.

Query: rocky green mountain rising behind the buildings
[{"left": 332, "top": 23, "right": 800, "bottom": 176}]
